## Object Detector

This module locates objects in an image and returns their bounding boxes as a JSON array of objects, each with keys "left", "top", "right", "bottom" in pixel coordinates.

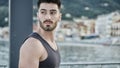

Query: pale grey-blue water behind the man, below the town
[{"left": 0, "top": 40, "right": 120, "bottom": 68}]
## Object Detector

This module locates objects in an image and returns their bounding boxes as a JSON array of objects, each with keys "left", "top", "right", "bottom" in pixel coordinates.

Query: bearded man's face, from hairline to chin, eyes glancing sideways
[{"left": 37, "top": 3, "right": 61, "bottom": 31}]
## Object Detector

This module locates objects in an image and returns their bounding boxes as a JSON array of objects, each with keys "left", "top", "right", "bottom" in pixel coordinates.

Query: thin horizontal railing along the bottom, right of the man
[{"left": 60, "top": 62, "right": 120, "bottom": 68}]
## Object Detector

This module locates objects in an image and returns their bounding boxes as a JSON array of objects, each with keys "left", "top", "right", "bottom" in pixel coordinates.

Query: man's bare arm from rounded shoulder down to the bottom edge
[{"left": 19, "top": 38, "right": 42, "bottom": 68}]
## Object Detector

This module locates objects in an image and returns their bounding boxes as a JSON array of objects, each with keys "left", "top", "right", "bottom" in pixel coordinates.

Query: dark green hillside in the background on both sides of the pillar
[{"left": 0, "top": 0, "right": 120, "bottom": 27}]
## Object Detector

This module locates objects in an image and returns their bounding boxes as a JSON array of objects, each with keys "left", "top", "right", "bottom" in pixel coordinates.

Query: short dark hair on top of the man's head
[{"left": 37, "top": 0, "right": 61, "bottom": 9}]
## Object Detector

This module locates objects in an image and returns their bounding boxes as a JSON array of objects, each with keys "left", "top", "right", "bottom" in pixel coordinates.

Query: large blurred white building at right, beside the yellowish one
[{"left": 95, "top": 12, "right": 120, "bottom": 37}]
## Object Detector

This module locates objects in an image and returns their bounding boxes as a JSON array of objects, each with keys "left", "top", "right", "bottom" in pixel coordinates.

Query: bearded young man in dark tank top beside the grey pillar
[{"left": 19, "top": 0, "right": 61, "bottom": 68}]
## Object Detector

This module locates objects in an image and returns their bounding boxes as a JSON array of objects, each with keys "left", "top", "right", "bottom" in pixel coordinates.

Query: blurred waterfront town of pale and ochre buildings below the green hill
[{"left": 0, "top": 11, "right": 120, "bottom": 42}]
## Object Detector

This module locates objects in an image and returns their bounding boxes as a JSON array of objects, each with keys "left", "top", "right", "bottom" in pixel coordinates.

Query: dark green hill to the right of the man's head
[{"left": 33, "top": 0, "right": 120, "bottom": 19}]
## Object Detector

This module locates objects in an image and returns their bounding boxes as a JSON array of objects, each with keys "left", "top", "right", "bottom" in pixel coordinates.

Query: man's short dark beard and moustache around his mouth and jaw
[{"left": 39, "top": 20, "right": 57, "bottom": 31}]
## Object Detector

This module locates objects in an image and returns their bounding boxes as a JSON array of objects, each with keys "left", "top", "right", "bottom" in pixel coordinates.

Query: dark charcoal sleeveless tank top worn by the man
[{"left": 29, "top": 32, "right": 60, "bottom": 68}]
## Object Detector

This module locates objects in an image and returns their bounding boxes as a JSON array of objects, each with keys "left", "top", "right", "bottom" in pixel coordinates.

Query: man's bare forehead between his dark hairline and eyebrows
[{"left": 39, "top": 3, "right": 59, "bottom": 10}]
